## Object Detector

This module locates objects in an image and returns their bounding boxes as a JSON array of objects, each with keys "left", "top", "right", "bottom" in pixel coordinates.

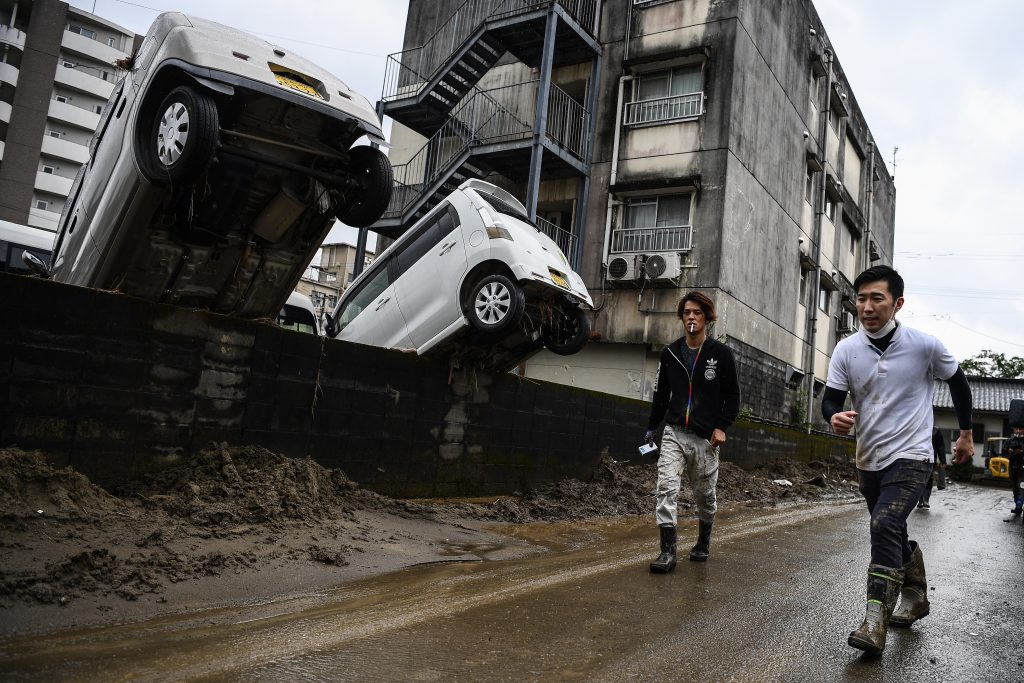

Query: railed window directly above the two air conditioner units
[{"left": 611, "top": 193, "right": 693, "bottom": 252}]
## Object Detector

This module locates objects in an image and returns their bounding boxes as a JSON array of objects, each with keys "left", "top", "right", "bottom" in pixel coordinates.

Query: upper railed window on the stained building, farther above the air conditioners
[{"left": 625, "top": 65, "right": 703, "bottom": 126}]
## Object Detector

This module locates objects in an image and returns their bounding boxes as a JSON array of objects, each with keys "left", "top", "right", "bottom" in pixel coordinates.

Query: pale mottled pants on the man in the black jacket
[{"left": 654, "top": 425, "right": 718, "bottom": 526}]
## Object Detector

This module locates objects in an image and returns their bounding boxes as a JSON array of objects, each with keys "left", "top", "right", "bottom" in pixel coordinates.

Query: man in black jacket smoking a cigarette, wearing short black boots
[{"left": 645, "top": 292, "right": 739, "bottom": 573}]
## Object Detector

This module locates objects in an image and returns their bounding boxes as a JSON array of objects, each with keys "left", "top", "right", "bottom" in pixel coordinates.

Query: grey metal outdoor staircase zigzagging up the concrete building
[{"left": 372, "top": 0, "right": 601, "bottom": 266}]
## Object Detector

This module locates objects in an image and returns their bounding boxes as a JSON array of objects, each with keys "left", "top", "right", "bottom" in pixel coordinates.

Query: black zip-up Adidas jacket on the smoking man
[{"left": 649, "top": 337, "right": 739, "bottom": 438}]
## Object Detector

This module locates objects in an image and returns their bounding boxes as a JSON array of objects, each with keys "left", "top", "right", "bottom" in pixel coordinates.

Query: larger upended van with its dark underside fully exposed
[{"left": 50, "top": 12, "right": 392, "bottom": 317}]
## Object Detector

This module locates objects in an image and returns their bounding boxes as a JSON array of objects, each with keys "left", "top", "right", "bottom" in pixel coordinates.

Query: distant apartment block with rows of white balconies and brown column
[{"left": 0, "top": 0, "right": 135, "bottom": 231}]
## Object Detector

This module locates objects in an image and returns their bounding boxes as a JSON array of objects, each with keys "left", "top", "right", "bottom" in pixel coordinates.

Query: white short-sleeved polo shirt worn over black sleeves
[{"left": 826, "top": 325, "right": 959, "bottom": 471}]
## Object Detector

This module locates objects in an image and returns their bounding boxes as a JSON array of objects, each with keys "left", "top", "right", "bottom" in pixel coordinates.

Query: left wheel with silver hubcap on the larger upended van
[{"left": 140, "top": 85, "right": 220, "bottom": 184}]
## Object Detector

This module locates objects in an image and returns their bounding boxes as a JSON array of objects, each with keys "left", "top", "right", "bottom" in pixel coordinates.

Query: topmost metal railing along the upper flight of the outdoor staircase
[{"left": 381, "top": 0, "right": 597, "bottom": 101}]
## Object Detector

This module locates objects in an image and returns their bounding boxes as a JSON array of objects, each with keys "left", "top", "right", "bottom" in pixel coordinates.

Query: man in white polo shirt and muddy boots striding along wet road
[{"left": 821, "top": 265, "right": 974, "bottom": 654}]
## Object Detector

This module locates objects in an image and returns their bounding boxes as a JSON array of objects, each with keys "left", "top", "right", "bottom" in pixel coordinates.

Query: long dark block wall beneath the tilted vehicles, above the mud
[{"left": 0, "top": 273, "right": 850, "bottom": 497}]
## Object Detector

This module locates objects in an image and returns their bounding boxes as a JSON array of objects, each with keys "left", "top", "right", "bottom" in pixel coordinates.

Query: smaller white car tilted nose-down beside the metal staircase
[{"left": 327, "top": 180, "right": 593, "bottom": 368}]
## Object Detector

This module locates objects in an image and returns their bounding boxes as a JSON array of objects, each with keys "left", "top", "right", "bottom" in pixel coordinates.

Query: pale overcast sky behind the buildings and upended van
[{"left": 71, "top": 0, "right": 1024, "bottom": 359}]
